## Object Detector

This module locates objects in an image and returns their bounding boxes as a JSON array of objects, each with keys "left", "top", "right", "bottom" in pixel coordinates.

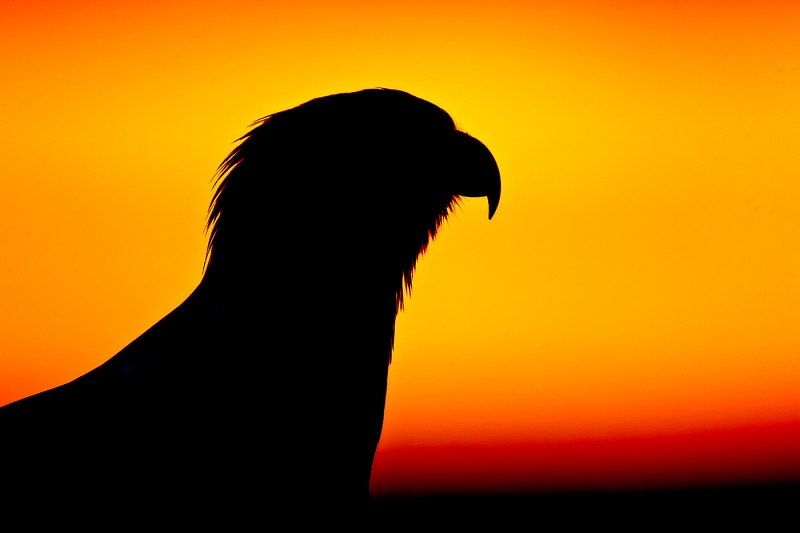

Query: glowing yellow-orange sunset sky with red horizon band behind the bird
[{"left": 0, "top": 0, "right": 800, "bottom": 495}]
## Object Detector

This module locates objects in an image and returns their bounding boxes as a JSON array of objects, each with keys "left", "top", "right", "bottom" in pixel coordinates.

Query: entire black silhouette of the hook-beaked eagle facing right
[{"left": 0, "top": 89, "right": 500, "bottom": 513}]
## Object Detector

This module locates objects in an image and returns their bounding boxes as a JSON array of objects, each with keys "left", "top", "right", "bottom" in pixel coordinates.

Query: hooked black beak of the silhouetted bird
[{"left": 453, "top": 131, "right": 500, "bottom": 220}]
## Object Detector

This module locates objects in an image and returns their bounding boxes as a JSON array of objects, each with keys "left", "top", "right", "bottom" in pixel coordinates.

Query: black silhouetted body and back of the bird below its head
[{"left": 0, "top": 276, "right": 388, "bottom": 514}]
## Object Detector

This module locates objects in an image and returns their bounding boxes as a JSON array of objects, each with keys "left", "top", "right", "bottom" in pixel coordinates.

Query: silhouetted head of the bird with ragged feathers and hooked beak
[{"left": 207, "top": 88, "right": 500, "bottom": 309}]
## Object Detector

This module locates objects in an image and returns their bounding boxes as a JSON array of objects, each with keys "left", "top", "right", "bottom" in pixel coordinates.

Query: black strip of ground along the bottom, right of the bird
[{"left": 372, "top": 483, "right": 800, "bottom": 531}]
